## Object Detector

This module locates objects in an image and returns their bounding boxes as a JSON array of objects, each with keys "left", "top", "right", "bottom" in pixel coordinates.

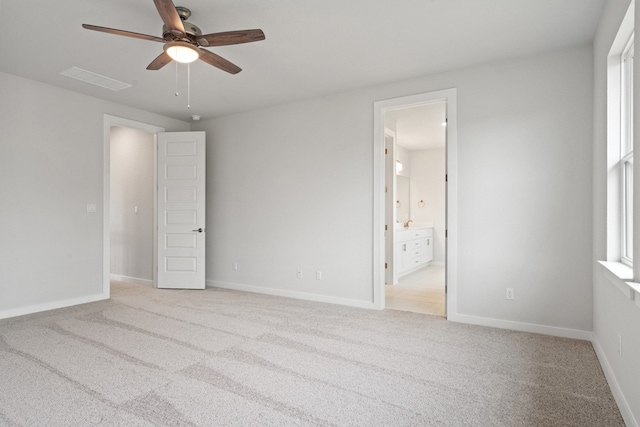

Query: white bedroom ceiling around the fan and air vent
[{"left": 0, "top": 0, "right": 606, "bottom": 120}]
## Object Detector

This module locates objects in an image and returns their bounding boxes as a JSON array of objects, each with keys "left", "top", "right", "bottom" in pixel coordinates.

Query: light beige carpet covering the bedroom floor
[{"left": 0, "top": 283, "right": 624, "bottom": 426}]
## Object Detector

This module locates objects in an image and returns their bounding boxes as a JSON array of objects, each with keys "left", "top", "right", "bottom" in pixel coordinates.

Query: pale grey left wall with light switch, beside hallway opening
[{"left": 0, "top": 73, "right": 189, "bottom": 318}]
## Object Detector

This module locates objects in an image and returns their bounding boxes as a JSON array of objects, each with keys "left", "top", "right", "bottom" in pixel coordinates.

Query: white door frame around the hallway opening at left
[{"left": 102, "top": 114, "right": 165, "bottom": 298}]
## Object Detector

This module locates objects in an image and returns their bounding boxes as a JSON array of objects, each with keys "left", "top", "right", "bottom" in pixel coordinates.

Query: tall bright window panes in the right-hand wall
[{"left": 618, "top": 35, "right": 634, "bottom": 265}]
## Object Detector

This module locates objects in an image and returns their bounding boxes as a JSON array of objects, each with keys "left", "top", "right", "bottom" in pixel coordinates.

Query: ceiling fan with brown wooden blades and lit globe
[{"left": 82, "top": 0, "right": 265, "bottom": 74}]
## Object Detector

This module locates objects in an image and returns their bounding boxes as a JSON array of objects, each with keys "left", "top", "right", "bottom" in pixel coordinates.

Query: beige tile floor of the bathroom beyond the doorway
[{"left": 385, "top": 265, "right": 445, "bottom": 317}]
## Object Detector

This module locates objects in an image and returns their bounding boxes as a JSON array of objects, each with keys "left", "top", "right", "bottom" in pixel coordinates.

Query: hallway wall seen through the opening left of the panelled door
[{"left": 110, "top": 126, "right": 155, "bottom": 284}]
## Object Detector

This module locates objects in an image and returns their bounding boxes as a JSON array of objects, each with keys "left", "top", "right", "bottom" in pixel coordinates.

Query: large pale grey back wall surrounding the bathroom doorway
[{"left": 194, "top": 46, "right": 593, "bottom": 331}]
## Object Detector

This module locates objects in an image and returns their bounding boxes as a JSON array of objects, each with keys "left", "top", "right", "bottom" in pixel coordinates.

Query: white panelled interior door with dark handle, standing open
[{"left": 156, "top": 132, "right": 206, "bottom": 289}]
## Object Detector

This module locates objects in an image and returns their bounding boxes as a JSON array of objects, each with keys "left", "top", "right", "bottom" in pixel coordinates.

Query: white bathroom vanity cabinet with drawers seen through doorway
[{"left": 395, "top": 228, "right": 433, "bottom": 277}]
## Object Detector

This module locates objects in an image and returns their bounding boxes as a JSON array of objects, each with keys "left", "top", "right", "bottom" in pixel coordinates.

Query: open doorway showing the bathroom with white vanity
[{"left": 384, "top": 101, "right": 447, "bottom": 317}]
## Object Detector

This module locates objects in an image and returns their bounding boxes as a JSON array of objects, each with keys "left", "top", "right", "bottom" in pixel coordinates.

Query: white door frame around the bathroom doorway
[{"left": 373, "top": 88, "right": 458, "bottom": 320}]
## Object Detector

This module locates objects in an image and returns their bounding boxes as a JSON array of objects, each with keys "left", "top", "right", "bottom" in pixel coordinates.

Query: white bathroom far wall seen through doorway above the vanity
[{"left": 410, "top": 148, "right": 446, "bottom": 263}]
